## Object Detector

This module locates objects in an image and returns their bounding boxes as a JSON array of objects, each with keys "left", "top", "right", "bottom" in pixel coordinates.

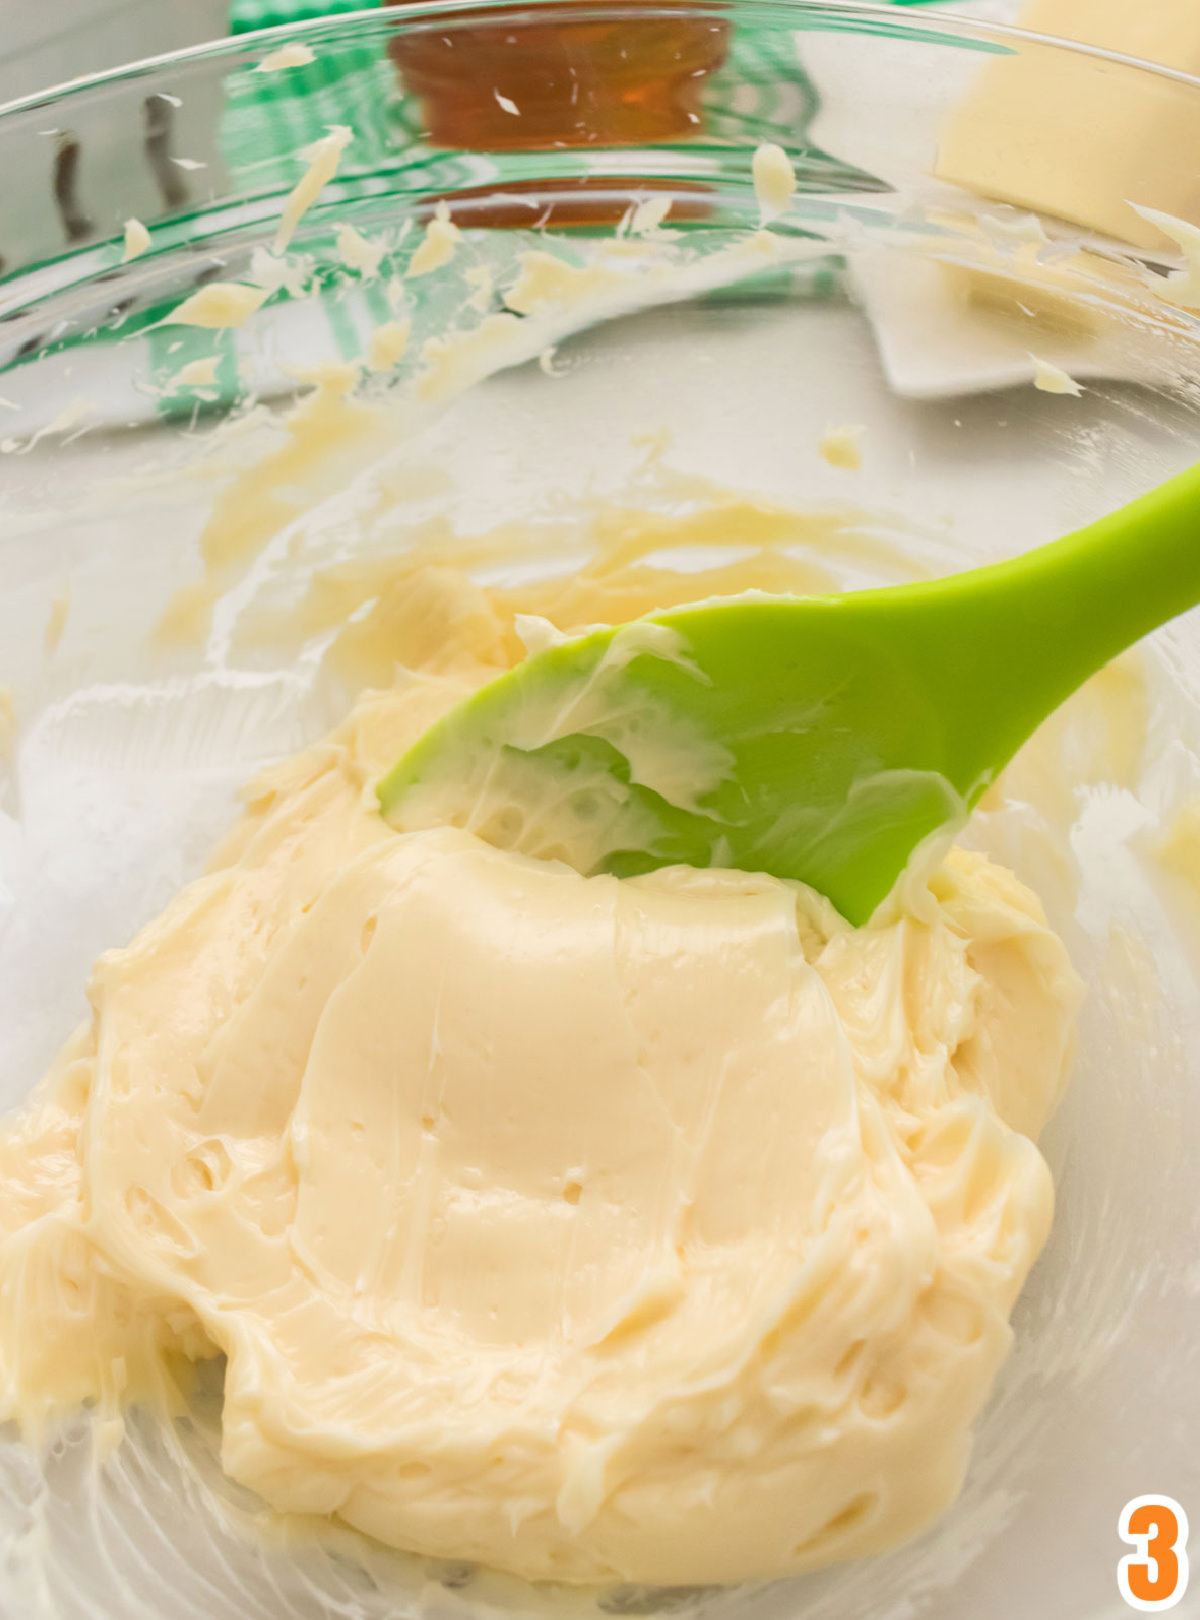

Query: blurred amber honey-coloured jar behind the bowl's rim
[{"left": 390, "top": 0, "right": 729, "bottom": 224}]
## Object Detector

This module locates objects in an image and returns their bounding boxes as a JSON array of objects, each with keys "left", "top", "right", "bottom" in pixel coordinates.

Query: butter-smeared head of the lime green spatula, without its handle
[{"left": 379, "top": 591, "right": 983, "bottom": 923}]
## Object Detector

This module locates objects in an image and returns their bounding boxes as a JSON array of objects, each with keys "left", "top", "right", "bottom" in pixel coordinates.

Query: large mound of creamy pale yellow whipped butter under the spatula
[{"left": 0, "top": 550, "right": 1080, "bottom": 1583}]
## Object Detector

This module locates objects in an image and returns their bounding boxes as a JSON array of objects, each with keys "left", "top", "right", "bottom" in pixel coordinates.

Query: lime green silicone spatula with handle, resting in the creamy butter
[{"left": 379, "top": 468, "right": 1200, "bottom": 923}]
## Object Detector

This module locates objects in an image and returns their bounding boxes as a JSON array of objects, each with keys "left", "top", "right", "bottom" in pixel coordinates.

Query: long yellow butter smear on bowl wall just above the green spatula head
[{"left": 230, "top": 489, "right": 919, "bottom": 690}]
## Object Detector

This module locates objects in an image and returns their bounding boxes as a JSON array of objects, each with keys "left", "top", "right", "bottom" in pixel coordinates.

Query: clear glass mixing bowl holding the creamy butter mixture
[{"left": 0, "top": 9, "right": 1200, "bottom": 1620}]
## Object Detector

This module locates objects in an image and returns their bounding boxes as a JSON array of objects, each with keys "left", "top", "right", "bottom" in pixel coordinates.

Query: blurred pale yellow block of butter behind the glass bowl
[{"left": 936, "top": 0, "right": 1200, "bottom": 249}]
